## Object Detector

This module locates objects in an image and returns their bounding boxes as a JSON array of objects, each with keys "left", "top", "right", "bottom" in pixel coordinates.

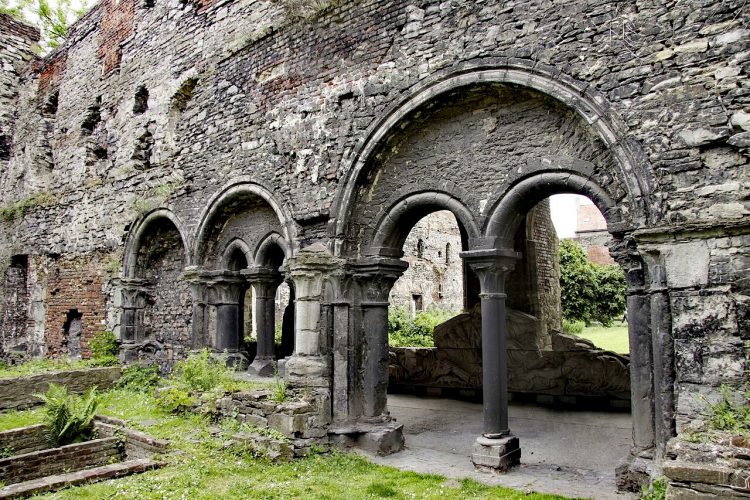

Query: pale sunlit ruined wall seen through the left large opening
[{"left": 390, "top": 212, "right": 464, "bottom": 312}]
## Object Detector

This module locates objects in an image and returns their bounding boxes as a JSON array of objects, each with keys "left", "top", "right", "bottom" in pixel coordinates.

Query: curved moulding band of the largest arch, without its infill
[{"left": 329, "top": 58, "right": 658, "bottom": 255}]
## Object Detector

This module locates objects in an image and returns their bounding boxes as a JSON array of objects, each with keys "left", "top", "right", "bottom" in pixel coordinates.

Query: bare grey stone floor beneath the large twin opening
[{"left": 371, "top": 395, "right": 635, "bottom": 499}]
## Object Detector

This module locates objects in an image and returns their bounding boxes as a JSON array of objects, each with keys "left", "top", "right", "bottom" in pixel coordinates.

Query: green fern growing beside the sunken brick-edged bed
[{"left": 35, "top": 384, "right": 99, "bottom": 446}]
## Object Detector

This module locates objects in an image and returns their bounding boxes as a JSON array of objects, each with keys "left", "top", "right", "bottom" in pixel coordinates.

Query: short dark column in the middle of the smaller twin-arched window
[{"left": 241, "top": 267, "right": 282, "bottom": 377}]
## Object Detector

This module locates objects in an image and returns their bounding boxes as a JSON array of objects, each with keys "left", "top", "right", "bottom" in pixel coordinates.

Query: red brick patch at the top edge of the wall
[{"left": 98, "top": 0, "right": 135, "bottom": 75}]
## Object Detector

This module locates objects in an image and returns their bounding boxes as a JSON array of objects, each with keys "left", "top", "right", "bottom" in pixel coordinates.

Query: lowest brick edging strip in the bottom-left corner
[{"left": 0, "top": 458, "right": 164, "bottom": 499}]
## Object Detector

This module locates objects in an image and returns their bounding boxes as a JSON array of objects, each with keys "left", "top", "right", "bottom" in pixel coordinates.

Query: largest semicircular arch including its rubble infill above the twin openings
[{"left": 330, "top": 62, "right": 658, "bottom": 255}]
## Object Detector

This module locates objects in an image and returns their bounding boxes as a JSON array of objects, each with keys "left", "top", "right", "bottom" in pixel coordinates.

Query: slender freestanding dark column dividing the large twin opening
[{"left": 461, "top": 249, "right": 521, "bottom": 471}]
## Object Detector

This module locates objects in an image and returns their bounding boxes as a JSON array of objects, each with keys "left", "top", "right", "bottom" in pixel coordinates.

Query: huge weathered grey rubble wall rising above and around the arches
[{"left": 0, "top": 0, "right": 750, "bottom": 476}]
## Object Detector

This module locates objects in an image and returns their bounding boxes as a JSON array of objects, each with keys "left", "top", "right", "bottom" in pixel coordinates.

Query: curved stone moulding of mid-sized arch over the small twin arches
[{"left": 190, "top": 178, "right": 297, "bottom": 265}]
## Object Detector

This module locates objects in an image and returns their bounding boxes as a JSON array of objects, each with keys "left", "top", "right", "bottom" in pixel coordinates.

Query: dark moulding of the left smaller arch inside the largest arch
[{"left": 367, "top": 192, "right": 480, "bottom": 258}]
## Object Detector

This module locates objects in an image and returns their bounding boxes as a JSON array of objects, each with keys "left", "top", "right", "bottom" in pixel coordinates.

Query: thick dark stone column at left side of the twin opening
[{"left": 351, "top": 257, "right": 408, "bottom": 422}]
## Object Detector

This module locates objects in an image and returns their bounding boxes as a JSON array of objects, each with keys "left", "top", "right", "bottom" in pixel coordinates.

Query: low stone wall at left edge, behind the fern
[{"left": 0, "top": 366, "right": 122, "bottom": 410}]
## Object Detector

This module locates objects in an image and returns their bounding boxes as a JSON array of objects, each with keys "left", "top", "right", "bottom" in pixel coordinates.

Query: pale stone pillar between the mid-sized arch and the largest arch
[{"left": 285, "top": 243, "right": 343, "bottom": 387}]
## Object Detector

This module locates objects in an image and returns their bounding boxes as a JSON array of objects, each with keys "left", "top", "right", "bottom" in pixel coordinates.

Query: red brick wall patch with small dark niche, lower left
[{"left": 45, "top": 256, "right": 105, "bottom": 358}]
